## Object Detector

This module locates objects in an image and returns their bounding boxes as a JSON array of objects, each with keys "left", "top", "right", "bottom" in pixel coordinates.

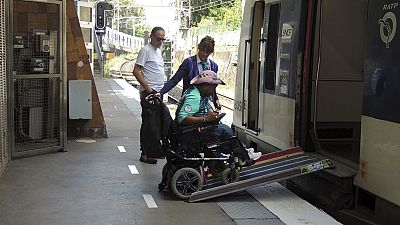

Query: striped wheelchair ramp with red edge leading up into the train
[{"left": 189, "top": 147, "right": 334, "bottom": 202}]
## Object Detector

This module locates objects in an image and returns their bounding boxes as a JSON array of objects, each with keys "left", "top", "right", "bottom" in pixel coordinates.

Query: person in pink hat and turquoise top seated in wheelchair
[{"left": 176, "top": 70, "right": 261, "bottom": 164}]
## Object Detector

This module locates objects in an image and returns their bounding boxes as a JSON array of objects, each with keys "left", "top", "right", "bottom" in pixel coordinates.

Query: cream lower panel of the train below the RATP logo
[{"left": 355, "top": 116, "right": 400, "bottom": 205}]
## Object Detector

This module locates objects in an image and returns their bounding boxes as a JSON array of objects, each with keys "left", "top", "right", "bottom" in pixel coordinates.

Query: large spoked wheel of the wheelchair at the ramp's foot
[{"left": 171, "top": 167, "right": 203, "bottom": 200}]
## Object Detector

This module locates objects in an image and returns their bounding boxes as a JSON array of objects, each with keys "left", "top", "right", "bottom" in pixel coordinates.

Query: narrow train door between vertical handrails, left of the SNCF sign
[{"left": 242, "top": 1, "right": 265, "bottom": 132}]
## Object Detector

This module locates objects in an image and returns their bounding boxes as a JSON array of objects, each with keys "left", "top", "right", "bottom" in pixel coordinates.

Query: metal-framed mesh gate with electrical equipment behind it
[{"left": 11, "top": 0, "right": 64, "bottom": 158}]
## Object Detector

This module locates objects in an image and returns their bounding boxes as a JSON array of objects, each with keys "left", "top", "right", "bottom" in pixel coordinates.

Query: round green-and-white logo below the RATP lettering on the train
[{"left": 378, "top": 12, "right": 397, "bottom": 48}]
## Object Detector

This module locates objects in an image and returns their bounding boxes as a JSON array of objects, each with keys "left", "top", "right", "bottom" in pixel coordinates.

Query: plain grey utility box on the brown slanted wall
[{"left": 68, "top": 80, "right": 92, "bottom": 119}]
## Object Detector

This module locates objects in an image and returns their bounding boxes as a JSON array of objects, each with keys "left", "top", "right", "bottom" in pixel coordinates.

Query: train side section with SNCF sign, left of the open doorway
[{"left": 233, "top": 0, "right": 306, "bottom": 152}]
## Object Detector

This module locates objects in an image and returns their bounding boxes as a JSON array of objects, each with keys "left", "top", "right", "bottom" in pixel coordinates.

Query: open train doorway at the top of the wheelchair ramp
[{"left": 308, "top": 0, "right": 368, "bottom": 168}]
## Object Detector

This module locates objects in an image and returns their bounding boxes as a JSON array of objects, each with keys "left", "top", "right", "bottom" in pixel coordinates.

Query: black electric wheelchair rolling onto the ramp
[{"left": 146, "top": 95, "right": 254, "bottom": 199}]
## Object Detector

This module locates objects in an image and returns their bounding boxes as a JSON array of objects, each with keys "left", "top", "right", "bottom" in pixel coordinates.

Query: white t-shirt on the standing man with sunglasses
[{"left": 136, "top": 43, "right": 165, "bottom": 91}]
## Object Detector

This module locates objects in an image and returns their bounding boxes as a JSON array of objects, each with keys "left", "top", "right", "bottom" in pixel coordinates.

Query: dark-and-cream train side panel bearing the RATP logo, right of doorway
[{"left": 355, "top": 0, "right": 400, "bottom": 206}]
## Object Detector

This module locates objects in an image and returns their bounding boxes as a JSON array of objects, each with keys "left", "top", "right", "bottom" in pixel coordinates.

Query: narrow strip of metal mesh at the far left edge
[{"left": 0, "top": 1, "right": 8, "bottom": 171}]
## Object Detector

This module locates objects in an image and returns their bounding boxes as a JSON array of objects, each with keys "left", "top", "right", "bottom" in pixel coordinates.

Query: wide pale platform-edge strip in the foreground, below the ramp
[{"left": 248, "top": 183, "right": 341, "bottom": 225}]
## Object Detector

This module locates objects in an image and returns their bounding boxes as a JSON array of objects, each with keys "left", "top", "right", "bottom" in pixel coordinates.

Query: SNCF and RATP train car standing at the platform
[{"left": 232, "top": 0, "right": 400, "bottom": 224}]
